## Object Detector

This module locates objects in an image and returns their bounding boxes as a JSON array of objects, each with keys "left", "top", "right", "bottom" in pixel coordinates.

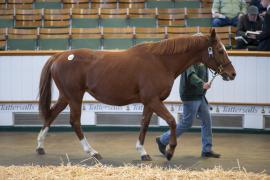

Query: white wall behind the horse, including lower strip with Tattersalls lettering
[{"left": 0, "top": 56, "right": 270, "bottom": 129}]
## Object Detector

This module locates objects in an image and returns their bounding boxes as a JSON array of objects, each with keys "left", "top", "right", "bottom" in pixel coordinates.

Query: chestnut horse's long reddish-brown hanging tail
[{"left": 38, "top": 55, "right": 55, "bottom": 121}]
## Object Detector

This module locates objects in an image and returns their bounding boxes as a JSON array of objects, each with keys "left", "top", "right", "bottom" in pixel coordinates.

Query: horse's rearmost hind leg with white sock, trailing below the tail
[{"left": 36, "top": 95, "right": 68, "bottom": 155}]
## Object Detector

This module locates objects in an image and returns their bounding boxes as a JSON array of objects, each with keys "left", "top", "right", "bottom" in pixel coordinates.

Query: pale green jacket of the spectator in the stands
[{"left": 212, "top": 0, "right": 247, "bottom": 18}]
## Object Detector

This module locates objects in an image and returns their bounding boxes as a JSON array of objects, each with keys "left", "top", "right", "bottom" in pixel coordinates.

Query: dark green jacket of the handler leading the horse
[{"left": 179, "top": 64, "right": 208, "bottom": 101}]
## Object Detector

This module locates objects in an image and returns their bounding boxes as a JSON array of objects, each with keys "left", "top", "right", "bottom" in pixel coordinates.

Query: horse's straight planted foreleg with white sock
[{"left": 136, "top": 106, "right": 153, "bottom": 161}]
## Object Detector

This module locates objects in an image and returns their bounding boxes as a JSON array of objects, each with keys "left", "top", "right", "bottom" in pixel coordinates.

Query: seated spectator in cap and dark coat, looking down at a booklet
[{"left": 236, "top": 6, "right": 263, "bottom": 50}]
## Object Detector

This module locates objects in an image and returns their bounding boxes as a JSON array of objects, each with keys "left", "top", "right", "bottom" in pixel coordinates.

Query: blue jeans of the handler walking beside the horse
[{"left": 160, "top": 97, "right": 212, "bottom": 152}]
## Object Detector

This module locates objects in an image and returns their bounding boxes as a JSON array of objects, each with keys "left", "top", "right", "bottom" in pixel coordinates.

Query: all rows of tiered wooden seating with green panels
[{"left": 0, "top": 0, "right": 240, "bottom": 50}]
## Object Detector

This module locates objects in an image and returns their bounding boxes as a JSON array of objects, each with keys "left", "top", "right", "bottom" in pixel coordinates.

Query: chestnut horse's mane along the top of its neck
[{"left": 135, "top": 35, "right": 209, "bottom": 55}]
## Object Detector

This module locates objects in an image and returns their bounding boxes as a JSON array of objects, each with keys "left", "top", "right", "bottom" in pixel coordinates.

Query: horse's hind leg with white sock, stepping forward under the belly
[{"left": 70, "top": 103, "right": 102, "bottom": 160}]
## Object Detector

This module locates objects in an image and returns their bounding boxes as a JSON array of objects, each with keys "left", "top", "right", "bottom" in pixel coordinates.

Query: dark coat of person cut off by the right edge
[{"left": 257, "top": 8, "right": 270, "bottom": 51}]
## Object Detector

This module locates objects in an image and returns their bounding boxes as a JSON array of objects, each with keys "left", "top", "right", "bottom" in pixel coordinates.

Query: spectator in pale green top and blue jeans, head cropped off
[{"left": 212, "top": 0, "right": 247, "bottom": 27}]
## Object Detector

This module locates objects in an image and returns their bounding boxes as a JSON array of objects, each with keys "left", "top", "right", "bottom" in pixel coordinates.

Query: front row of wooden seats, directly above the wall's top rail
[{"left": 0, "top": 26, "right": 236, "bottom": 50}]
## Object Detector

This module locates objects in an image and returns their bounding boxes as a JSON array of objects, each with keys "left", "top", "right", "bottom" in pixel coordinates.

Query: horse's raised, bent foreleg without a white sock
[{"left": 149, "top": 99, "right": 177, "bottom": 160}]
